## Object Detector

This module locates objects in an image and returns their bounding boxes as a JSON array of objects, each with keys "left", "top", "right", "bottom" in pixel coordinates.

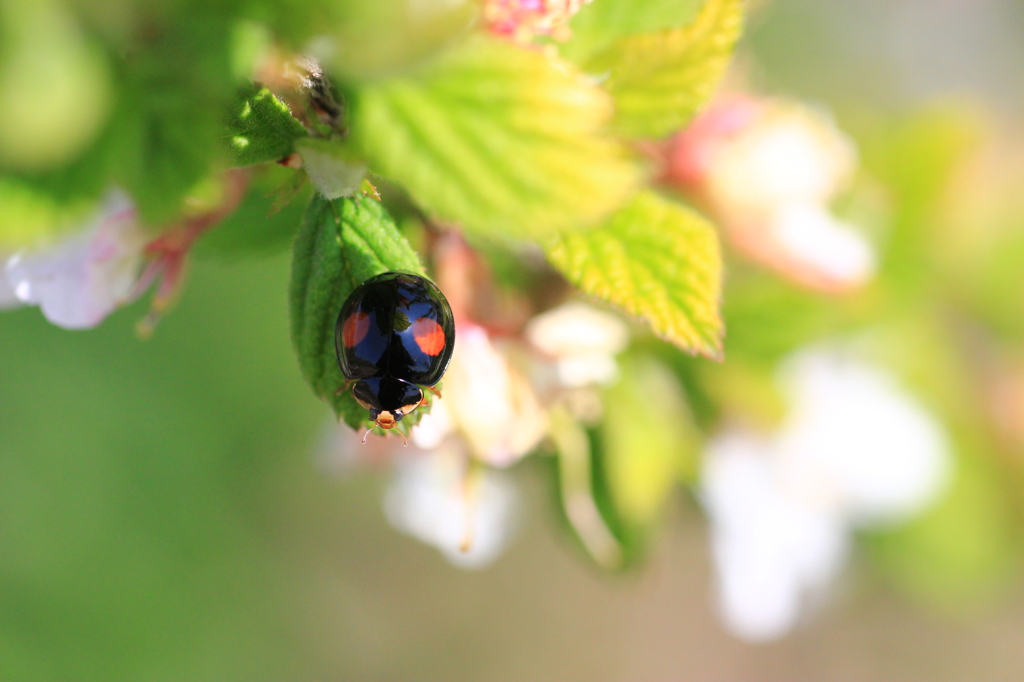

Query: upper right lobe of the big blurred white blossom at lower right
[{"left": 777, "top": 349, "right": 952, "bottom": 524}]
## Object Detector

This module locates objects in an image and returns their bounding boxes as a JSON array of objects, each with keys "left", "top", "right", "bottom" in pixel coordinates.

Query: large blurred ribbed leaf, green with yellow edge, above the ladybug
[{"left": 352, "top": 37, "right": 638, "bottom": 238}]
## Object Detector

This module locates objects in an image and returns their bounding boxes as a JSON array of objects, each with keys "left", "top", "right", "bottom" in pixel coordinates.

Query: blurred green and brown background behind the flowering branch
[{"left": 0, "top": 0, "right": 1024, "bottom": 682}]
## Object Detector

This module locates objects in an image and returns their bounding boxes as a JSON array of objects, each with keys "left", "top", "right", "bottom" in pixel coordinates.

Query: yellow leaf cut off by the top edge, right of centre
[{"left": 586, "top": 0, "right": 743, "bottom": 137}]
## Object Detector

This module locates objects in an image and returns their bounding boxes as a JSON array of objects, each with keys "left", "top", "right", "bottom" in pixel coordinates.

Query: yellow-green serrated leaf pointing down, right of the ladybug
[{"left": 547, "top": 191, "right": 723, "bottom": 358}]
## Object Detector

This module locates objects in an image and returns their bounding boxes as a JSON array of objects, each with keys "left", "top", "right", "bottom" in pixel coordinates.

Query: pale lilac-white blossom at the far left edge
[{"left": 5, "top": 190, "right": 150, "bottom": 329}]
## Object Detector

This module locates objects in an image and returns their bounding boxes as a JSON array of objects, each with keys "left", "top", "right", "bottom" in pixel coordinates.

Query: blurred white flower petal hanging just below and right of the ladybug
[{"left": 384, "top": 450, "right": 518, "bottom": 568}]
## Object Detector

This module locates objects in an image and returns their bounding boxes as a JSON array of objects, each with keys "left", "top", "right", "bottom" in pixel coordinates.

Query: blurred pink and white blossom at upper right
[{"left": 666, "top": 97, "right": 877, "bottom": 292}]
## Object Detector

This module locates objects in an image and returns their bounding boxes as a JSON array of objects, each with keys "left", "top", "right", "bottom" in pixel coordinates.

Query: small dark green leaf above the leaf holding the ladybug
[{"left": 227, "top": 85, "right": 307, "bottom": 166}]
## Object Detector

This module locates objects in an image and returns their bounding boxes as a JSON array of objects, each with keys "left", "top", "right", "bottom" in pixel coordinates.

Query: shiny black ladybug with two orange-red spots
[{"left": 334, "top": 272, "right": 455, "bottom": 442}]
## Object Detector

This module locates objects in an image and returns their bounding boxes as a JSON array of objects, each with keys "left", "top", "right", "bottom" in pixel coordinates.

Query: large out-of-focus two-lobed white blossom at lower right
[{"left": 701, "top": 349, "right": 951, "bottom": 641}]
